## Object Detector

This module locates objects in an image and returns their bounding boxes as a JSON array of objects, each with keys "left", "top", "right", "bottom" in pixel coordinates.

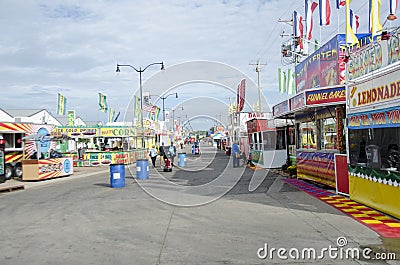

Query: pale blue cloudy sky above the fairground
[{"left": 0, "top": 0, "right": 399, "bottom": 130}]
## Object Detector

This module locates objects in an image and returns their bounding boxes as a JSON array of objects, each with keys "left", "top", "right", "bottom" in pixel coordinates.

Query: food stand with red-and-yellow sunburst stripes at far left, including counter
[{"left": 0, "top": 122, "right": 73, "bottom": 180}]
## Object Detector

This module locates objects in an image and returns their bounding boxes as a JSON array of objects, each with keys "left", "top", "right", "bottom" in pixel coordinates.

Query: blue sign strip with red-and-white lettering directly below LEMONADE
[{"left": 349, "top": 107, "right": 400, "bottom": 129}]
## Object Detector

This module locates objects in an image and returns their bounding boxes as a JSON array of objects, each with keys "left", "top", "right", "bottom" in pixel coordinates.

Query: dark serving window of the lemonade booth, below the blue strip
[{"left": 349, "top": 128, "right": 400, "bottom": 171}]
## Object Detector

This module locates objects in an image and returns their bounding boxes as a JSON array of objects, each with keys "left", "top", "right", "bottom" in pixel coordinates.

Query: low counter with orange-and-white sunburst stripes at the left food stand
[{"left": 22, "top": 157, "right": 74, "bottom": 180}]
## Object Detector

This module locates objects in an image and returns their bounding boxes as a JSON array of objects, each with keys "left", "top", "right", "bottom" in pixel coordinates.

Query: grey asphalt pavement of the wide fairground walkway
[{"left": 0, "top": 146, "right": 398, "bottom": 265}]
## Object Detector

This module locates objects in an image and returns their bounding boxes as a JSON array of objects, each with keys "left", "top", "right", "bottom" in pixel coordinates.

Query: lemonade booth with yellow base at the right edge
[{"left": 347, "top": 29, "right": 400, "bottom": 218}]
